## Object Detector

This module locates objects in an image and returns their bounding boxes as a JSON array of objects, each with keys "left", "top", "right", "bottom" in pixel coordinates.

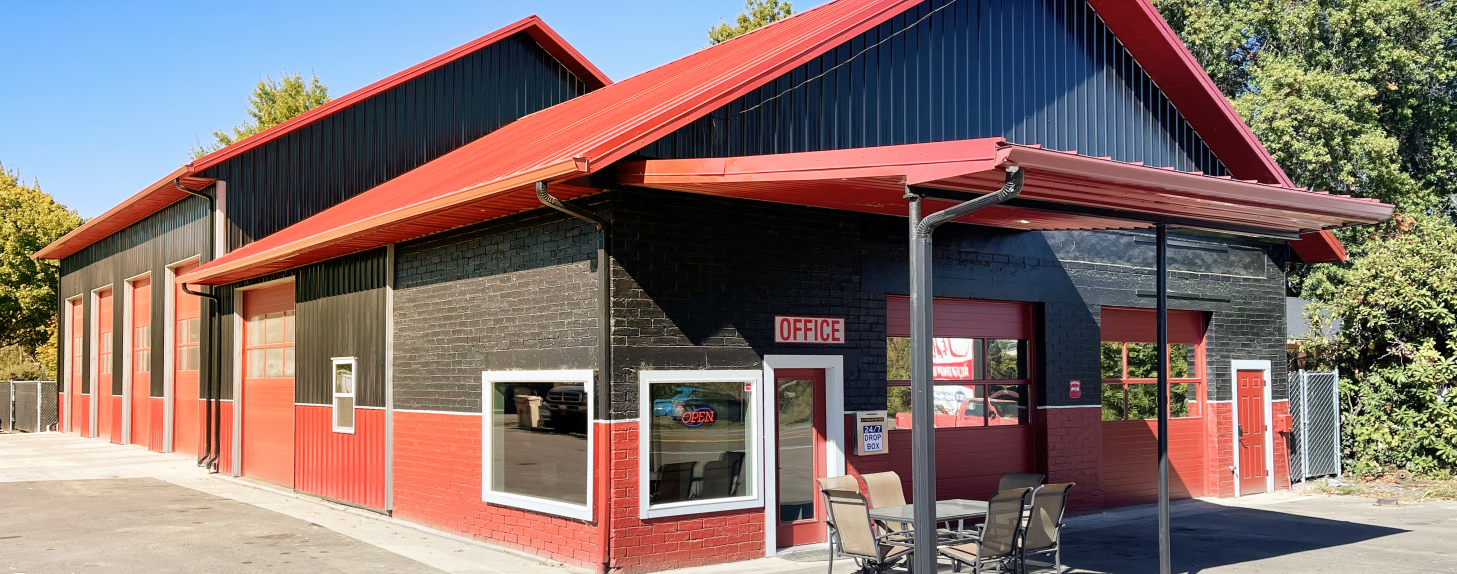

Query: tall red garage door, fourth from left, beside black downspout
[{"left": 169, "top": 264, "right": 203, "bottom": 456}]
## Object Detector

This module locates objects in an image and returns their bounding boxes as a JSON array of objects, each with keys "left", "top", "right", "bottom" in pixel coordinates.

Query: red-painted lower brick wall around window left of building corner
[{"left": 393, "top": 411, "right": 602, "bottom": 568}]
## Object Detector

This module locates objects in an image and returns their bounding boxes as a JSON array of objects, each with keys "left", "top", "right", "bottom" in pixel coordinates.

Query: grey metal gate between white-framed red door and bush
[{"left": 1289, "top": 371, "right": 1340, "bottom": 481}]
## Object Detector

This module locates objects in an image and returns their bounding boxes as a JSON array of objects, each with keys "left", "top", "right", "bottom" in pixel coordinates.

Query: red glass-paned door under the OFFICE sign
[{"left": 774, "top": 369, "right": 825, "bottom": 548}]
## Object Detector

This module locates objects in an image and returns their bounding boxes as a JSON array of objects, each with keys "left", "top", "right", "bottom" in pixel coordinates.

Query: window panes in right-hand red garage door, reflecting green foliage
[{"left": 1101, "top": 341, "right": 1203, "bottom": 421}]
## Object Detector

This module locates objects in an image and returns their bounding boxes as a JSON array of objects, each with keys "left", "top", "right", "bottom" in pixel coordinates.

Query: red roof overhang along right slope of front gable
[{"left": 1088, "top": 0, "right": 1346, "bottom": 264}]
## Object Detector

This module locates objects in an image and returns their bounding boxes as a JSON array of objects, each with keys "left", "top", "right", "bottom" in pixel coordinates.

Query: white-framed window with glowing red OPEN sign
[{"left": 643, "top": 371, "right": 761, "bottom": 517}]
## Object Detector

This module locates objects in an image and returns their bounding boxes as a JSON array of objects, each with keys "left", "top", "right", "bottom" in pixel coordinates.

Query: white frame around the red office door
[{"left": 759, "top": 355, "right": 845, "bottom": 557}]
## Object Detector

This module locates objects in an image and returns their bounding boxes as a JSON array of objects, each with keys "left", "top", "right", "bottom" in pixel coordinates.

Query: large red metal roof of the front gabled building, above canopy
[{"left": 173, "top": 0, "right": 1375, "bottom": 284}]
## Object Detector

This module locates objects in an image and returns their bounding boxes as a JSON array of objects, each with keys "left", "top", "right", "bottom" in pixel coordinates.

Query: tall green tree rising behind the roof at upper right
[{"left": 1154, "top": 0, "right": 1457, "bottom": 215}]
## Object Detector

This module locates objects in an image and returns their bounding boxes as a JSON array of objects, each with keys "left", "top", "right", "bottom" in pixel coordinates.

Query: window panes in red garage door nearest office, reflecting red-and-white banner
[{"left": 886, "top": 337, "right": 1030, "bottom": 430}]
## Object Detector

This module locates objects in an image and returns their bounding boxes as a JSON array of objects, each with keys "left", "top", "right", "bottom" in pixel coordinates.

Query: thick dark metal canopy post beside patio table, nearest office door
[{"left": 906, "top": 192, "right": 937, "bottom": 573}]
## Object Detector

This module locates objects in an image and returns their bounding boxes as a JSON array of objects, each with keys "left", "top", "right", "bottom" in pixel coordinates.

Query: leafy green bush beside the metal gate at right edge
[{"left": 1301, "top": 216, "right": 1457, "bottom": 478}]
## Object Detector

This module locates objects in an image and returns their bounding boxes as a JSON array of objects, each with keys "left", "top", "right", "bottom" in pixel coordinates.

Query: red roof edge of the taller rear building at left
[{"left": 32, "top": 16, "right": 612, "bottom": 259}]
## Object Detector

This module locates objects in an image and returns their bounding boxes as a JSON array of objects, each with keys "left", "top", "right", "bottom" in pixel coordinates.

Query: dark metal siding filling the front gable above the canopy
[{"left": 641, "top": 0, "right": 1227, "bottom": 175}]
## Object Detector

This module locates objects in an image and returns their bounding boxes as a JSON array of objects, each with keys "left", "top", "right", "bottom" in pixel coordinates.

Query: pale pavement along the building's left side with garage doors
[{"left": 0, "top": 433, "right": 586, "bottom": 574}]
